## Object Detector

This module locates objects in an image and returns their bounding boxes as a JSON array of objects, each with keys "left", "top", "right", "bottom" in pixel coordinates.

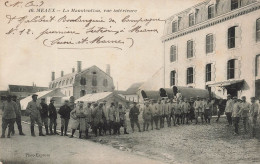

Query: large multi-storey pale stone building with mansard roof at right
[{"left": 162, "top": 0, "right": 260, "bottom": 98}]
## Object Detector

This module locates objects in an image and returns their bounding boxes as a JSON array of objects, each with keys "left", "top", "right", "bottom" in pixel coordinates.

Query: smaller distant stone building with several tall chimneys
[{"left": 49, "top": 61, "right": 115, "bottom": 99}]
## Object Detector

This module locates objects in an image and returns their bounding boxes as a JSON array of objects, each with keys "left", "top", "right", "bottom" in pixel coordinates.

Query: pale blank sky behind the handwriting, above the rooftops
[{"left": 0, "top": 0, "right": 202, "bottom": 90}]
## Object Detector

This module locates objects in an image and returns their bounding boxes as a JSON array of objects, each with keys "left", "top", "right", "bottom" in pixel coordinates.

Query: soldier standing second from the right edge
[{"left": 240, "top": 96, "right": 250, "bottom": 133}]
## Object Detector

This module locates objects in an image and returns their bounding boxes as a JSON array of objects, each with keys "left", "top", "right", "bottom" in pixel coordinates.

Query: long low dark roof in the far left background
[{"left": 8, "top": 85, "right": 48, "bottom": 93}]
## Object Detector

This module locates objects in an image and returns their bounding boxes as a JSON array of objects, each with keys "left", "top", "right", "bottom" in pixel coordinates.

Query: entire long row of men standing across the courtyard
[{"left": 1, "top": 94, "right": 259, "bottom": 138}]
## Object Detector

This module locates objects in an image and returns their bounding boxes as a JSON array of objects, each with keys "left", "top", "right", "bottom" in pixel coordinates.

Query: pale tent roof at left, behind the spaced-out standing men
[{"left": 20, "top": 89, "right": 65, "bottom": 110}]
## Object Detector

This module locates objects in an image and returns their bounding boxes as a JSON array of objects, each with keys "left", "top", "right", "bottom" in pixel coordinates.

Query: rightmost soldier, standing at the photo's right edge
[{"left": 249, "top": 97, "right": 259, "bottom": 137}]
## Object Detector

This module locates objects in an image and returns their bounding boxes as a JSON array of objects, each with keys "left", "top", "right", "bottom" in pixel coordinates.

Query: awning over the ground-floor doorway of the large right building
[{"left": 208, "top": 79, "right": 244, "bottom": 90}]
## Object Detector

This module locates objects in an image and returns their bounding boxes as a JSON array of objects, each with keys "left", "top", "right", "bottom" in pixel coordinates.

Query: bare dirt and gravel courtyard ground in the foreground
[{"left": 0, "top": 117, "right": 260, "bottom": 164}]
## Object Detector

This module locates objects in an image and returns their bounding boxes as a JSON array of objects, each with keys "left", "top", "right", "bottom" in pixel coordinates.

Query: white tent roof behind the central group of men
[{"left": 76, "top": 92, "right": 127, "bottom": 102}]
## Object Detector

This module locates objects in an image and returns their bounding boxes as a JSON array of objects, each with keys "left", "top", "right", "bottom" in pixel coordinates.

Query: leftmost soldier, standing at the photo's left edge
[{"left": 1, "top": 95, "right": 16, "bottom": 138}]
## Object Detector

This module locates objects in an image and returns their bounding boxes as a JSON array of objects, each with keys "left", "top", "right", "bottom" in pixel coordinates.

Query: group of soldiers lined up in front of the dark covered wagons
[{"left": 129, "top": 96, "right": 216, "bottom": 132}]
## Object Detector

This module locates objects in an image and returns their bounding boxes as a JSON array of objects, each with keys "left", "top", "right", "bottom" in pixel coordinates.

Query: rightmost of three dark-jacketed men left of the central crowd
[{"left": 58, "top": 100, "right": 72, "bottom": 136}]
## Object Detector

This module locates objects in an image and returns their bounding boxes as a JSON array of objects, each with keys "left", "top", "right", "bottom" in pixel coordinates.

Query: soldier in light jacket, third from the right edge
[{"left": 232, "top": 97, "right": 241, "bottom": 135}]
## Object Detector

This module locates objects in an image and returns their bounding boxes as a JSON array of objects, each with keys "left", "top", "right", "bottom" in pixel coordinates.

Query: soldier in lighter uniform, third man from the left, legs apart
[{"left": 26, "top": 94, "right": 45, "bottom": 137}]
